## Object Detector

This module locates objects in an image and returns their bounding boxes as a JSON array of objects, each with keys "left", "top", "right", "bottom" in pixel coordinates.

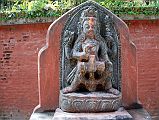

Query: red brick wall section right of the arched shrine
[{"left": 127, "top": 20, "right": 159, "bottom": 116}]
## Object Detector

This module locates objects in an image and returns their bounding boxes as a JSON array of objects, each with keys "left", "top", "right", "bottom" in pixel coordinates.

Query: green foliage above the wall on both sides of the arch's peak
[{"left": 0, "top": 0, "right": 159, "bottom": 21}]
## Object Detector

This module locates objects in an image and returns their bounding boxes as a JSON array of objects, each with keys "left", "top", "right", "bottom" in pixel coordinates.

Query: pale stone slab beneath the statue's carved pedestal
[{"left": 52, "top": 108, "right": 132, "bottom": 120}]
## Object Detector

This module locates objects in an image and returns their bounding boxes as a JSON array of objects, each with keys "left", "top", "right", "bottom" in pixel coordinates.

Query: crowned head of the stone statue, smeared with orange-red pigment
[{"left": 80, "top": 7, "right": 99, "bottom": 38}]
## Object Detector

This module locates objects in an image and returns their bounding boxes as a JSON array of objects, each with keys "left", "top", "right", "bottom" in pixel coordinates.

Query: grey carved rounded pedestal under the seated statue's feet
[{"left": 60, "top": 92, "right": 121, "bottom": 112}]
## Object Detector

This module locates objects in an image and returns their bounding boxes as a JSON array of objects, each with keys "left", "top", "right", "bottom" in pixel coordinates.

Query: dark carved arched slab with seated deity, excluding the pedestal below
[{"left": 60, "top": 1, "right": 121, "bottom": 93}]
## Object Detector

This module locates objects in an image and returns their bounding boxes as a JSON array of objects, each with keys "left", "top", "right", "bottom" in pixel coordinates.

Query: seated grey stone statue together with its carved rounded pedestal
[{"left": 60, "top": 6, "right": 121, "bottom": 112}]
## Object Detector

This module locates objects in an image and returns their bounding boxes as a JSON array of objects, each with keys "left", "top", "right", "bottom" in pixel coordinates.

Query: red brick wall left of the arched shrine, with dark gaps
[{"left": 0, "top": 23, "right": 50, "bottom": 120}]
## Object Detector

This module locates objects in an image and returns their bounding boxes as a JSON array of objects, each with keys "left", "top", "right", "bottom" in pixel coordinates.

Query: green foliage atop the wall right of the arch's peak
[{"left": 96, "top": 0, "right": 159, "bottom": 15}]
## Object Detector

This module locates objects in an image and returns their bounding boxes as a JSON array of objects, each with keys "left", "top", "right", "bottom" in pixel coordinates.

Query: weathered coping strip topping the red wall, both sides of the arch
[{"left": 0, "top": 15, "right": 159, "bottom": 26}]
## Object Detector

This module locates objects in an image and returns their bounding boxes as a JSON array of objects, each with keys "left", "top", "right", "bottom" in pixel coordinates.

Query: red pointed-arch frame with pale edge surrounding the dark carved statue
[{"left": 35, "top": 1, "right": 137, "bottom": 111}]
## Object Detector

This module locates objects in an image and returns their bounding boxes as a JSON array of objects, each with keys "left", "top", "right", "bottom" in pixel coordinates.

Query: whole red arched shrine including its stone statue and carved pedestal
[{"left": 35, "top": 1, "right": 137, "bottom": 112}]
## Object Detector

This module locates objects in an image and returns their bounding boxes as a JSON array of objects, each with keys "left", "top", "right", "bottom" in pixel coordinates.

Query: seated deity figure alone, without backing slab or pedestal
[{"left": 62, "top": 8, "right": 119, "bottom": 95}]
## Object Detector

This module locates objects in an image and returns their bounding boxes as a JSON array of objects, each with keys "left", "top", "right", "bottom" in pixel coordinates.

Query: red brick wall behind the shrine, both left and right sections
[{"left": 0, "top": 20, "right": 159, "bottom": 120}]
